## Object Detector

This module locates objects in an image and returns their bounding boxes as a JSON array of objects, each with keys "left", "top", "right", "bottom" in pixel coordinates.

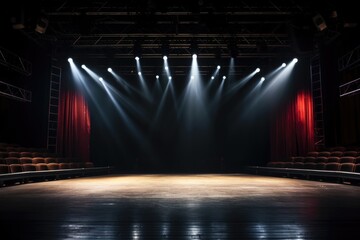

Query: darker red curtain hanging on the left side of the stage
[{"left": 58, "top": 90, "right": 90, "bottom": 162}]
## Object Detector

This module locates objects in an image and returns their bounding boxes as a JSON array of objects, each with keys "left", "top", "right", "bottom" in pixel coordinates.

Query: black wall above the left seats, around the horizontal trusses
[{"left": 0, "top": 12, "right": 50, "bottom": 147}]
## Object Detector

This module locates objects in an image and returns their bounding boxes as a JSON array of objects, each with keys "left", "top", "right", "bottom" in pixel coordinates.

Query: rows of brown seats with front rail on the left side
[{"left": 0, "top": 143, "right": 108, "bottom": 187}]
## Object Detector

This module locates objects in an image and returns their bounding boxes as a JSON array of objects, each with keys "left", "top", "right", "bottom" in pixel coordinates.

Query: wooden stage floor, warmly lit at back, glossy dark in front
[{"left": 0, "top": 174, "right": 360, "bottom": 240}]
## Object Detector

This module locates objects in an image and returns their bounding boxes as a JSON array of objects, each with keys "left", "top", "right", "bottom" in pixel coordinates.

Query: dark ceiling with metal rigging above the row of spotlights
[{"left": 4, "top": 0, "right": 358, "bottom": 76}]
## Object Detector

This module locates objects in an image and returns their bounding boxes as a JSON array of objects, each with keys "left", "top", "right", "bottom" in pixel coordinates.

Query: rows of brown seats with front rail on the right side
[{"left": 250, "top": 147, "right": 360, "bottom": 184}]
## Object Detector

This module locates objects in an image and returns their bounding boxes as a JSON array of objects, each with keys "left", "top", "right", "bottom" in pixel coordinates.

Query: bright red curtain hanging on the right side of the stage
[{"left": 271, "top": 91, "right": 314, "bottom": 161}]
